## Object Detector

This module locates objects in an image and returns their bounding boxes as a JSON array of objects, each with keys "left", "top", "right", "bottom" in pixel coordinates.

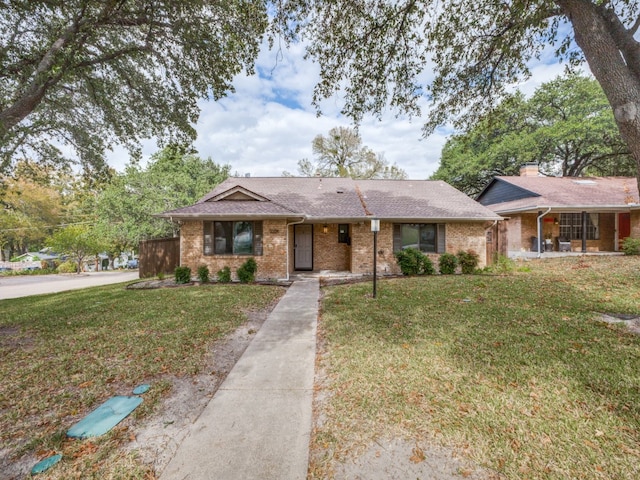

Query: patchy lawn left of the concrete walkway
[{"left": 0, "top": 284, "right": 284, "bottom": 478}]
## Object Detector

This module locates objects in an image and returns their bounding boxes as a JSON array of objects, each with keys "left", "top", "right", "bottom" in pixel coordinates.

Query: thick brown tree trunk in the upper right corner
[{"left": 556, "top": 0, "right": 640, "bottom": 196}]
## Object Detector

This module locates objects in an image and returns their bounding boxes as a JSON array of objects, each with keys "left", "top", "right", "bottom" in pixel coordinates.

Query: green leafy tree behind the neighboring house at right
[{"left": 431, "top": 75, "right": 635, "bottom": 196}]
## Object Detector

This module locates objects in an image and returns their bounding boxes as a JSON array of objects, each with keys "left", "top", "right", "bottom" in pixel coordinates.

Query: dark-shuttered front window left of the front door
[{"left": 203, "top": 221, "right": 262, "bottom": 255}]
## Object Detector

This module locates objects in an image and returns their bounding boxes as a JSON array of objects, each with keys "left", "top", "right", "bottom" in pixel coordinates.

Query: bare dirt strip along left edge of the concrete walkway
[{"left": 127, "top": 310, "right": 270, "bottom": 476}]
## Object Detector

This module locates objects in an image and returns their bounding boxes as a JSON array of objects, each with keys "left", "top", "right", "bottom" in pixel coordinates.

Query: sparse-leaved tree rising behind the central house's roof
[{"left": 284, "top": 127, "right": 407, "bottom": 179}]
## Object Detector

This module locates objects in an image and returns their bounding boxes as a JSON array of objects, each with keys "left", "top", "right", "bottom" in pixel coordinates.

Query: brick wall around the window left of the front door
[{"left": 180, "top": 220, "right": 287, "bottom": 279}]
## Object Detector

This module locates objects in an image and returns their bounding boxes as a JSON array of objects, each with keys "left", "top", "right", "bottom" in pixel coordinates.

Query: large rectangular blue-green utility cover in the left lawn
[{"left": 67, "top": 397, "right": 142, "bottom": 438}]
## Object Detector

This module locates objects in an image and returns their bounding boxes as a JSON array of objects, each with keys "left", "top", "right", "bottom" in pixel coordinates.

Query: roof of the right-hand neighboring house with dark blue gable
[{"left": 477, "top": 176, "right": 640, "bottom": 215}]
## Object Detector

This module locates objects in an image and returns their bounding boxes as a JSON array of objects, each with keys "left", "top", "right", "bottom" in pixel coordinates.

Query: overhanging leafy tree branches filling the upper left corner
[{"left": 0, "top": 0, "right": 267, "bottom": 176}]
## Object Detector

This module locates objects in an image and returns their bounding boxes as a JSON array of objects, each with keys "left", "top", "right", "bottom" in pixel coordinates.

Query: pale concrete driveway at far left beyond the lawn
[{"left": 0, "top": 270, "right": 138, "bottom": 300}]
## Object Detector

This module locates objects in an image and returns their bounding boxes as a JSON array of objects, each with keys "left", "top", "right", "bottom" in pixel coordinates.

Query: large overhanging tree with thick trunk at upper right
[{"left": 276, "top": 0, "right": 640, "bottom": 189}]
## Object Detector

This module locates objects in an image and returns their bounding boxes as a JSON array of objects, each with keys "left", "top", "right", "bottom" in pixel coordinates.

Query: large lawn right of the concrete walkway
[{"left": 310, "top": 257, "right": 640, "bottom": 479}]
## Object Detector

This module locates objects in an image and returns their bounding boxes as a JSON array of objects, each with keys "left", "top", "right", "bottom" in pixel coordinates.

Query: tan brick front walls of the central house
[{"left": 180, "top": 220, "right": 486, "bottom": 279}]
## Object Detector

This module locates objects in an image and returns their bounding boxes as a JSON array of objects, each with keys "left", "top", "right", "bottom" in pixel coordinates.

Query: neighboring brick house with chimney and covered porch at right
[{"left": 477, "top": 164, "right": 640, "bottom": 255}]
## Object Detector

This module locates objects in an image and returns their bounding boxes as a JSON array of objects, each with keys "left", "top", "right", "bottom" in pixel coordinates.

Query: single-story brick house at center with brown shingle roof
[{"left": 160, "top": 177, "right": 500, "bottom": 278}]
